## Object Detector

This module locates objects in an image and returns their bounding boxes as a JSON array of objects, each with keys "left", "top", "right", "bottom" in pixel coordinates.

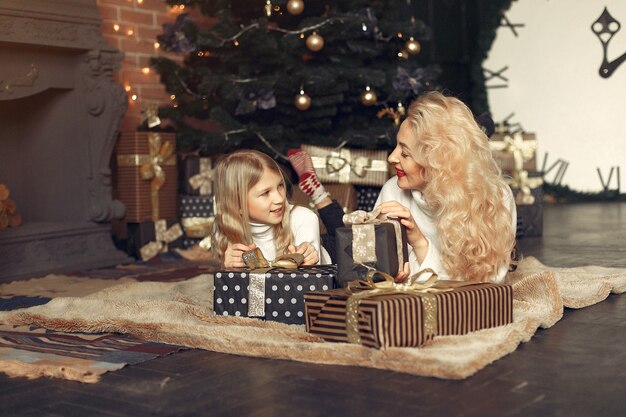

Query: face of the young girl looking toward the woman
[{"left": 248, "top": 168, "right": 287, "bottom": 225}]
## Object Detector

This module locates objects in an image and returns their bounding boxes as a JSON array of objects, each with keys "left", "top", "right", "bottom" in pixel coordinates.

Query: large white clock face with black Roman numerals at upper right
[{"left": 483, "top": 0, "right": 626, "bottom": 192}]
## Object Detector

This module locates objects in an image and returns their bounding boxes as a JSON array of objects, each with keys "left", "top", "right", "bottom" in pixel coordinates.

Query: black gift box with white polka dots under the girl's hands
[{"left": 213, "top": 265, "right": 337, "bottom": 324}]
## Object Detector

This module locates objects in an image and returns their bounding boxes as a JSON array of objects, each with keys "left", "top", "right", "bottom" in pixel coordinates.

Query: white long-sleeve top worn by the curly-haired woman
[{"left": 376, "top": 177, "right": 517, "bottom": 282}]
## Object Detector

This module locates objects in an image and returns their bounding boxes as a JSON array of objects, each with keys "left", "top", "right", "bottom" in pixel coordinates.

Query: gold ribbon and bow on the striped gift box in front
[{"left": 346, "top": 268, "right": 482, "bottom": 344}]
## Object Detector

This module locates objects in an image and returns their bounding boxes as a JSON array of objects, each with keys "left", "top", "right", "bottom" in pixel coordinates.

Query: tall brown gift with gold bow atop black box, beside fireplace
[{"left": 115, "top": 132, "right": 182, "bottom": 260}]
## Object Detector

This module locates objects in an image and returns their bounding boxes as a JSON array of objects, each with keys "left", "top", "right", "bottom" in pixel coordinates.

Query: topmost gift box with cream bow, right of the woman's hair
[{"left": 489, "top": 132, "right": 537, "bottom": 175}]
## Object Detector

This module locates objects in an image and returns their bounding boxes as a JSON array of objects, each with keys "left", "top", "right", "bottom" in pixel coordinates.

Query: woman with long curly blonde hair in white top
[{"left": 377, "top": 92, "right": 517, "bottom": 282}]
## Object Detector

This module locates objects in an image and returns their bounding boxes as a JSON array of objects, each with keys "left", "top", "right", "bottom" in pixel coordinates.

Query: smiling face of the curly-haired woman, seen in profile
[{"left": 387, "top": 120, "right": 424, "bottom": 190}]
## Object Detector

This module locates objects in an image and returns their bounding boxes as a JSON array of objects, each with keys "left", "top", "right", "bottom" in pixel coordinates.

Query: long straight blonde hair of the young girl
[{"left": 211, "top": 150, "right": 293, "bottom": 259}]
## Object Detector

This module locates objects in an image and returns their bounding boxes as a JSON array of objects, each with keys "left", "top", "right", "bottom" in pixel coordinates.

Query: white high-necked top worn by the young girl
[{"left": 250, "top": 206, "right": 330, "bottom": 265}]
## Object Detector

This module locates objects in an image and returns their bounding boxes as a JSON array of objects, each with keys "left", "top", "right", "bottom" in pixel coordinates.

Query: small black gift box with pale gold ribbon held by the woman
[{"left": 336, "top": 210, "right": 409, "bottom": 285}]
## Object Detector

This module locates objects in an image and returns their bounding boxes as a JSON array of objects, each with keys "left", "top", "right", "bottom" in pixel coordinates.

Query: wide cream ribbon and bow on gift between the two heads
[{"left": 309, "top": 148, "right": 387, "bottom": 184}]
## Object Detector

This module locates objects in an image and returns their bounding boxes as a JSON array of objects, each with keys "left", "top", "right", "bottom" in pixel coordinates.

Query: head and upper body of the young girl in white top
[{"left": 211, "top": 150, "right": 329, "bottom": 268}]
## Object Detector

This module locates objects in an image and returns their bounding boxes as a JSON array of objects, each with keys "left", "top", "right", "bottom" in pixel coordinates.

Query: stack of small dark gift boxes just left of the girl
[{"left": 179, "top": 155, "right": 215, "bottom": 248}]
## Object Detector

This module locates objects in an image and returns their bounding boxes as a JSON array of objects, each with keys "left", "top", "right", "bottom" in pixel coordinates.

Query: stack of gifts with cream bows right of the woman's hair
[{"left": 489, "top": 133, "right": 543, "bottom": 238}]
